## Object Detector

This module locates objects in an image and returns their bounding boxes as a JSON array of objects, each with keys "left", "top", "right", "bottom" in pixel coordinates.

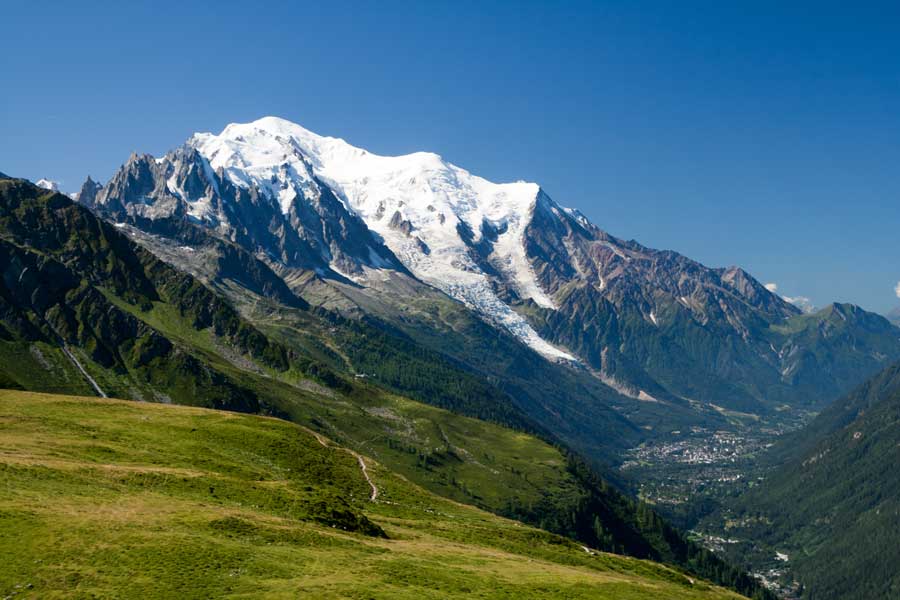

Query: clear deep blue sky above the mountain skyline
[{"left": 0, "top": 0, "right": 900, "bottom": 311}]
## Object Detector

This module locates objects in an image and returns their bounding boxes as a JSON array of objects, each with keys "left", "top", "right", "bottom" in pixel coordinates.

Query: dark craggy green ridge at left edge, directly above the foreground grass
[{"left": 0, "top": 179, "right": 304, "bottom": 412}]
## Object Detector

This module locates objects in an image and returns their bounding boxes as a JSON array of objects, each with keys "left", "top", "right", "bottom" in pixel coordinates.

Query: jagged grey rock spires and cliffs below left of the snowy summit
[{"left": 89, "top": 146, "right": 403, "bottom": 277}]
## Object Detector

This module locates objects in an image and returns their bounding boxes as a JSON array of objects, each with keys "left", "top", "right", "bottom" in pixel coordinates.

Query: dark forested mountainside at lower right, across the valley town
[{"left": 712, "top": 363, "right": 900, "bottom": 600}]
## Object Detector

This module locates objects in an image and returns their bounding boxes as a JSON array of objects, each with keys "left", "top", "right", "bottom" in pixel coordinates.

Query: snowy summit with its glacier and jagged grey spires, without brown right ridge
[{"left": 85, "top": 117, "right": 576, "bottom": 360}]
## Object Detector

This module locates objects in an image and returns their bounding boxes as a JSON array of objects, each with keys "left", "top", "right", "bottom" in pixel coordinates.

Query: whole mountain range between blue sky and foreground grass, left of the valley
[{"left": 7, "top": 117, "right": 900, "bottom": 598}]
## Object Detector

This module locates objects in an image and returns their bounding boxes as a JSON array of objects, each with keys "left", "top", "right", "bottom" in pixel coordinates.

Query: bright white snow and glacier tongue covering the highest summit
[{"left": 188, "top": 117, "right": 575, "bottom": 360}]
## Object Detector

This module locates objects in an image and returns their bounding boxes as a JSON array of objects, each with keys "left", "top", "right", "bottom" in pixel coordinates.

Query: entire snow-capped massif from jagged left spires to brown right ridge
[{"left": 81, "top": 117, "right": 900, "bottom": 409}]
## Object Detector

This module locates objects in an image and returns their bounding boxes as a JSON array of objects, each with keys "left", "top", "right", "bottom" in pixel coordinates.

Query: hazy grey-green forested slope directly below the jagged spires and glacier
[{"left": 79, "top": 196, "right": 642, "bottom": 454}]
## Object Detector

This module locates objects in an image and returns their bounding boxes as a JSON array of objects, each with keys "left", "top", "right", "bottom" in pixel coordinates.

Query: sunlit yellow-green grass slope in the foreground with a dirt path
[{"left": 0, "top": 391, "right": 738, "bottom": 600}]
